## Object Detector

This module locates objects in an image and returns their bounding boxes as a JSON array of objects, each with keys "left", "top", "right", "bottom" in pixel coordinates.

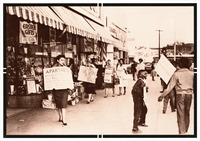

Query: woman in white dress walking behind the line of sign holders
[{"left": 116, "top": 59, "right": 128, "bottom": 96}]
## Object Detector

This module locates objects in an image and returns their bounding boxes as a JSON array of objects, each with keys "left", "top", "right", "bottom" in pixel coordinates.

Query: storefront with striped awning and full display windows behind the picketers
[{"left": 5, "top": 6, "right": 114, "bottom": 108}]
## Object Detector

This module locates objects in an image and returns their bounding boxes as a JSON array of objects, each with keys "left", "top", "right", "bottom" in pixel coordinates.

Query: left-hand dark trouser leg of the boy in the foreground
[{"left": 133, "top": 95, "right": 142, "bottom": 129}]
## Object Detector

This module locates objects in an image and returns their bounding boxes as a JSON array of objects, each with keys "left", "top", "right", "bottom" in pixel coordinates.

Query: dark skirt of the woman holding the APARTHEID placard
[{"left": 53, "top": 90, "right": 69, "bottom": 108}]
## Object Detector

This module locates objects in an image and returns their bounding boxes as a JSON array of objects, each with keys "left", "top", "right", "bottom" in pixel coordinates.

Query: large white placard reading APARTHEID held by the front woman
[{"left": 43, "top": 67, "right": 74, "bottom": 90}]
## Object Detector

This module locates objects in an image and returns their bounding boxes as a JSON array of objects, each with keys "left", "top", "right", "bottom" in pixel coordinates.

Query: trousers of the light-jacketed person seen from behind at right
[{"left": 176, "top": 94, "right": 192, "bottom": 134}]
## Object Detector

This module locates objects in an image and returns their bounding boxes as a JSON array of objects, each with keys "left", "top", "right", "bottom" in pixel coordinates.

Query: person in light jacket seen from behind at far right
[{"left": 158, "top": 58, "right": 194, "bottom": 134}]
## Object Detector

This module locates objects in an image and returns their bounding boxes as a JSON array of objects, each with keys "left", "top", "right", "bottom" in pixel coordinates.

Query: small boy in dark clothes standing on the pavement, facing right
[{"left": 132, "top": 70, "right": 147, "bottom": 132}]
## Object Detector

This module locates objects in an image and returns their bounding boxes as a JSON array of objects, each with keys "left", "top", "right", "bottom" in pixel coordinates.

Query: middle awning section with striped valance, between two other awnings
[{"left": 51, "top": 6, "right": 100, "bottom": 39}]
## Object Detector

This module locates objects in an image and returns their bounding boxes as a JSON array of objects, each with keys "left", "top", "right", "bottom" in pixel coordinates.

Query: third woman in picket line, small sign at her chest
[{"left": 104, "top": 59, "right": 115, "bottom": 98}]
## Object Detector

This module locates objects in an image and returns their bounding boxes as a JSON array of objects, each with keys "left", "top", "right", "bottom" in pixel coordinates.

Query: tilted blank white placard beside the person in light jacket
[{"left": 155, "top": 55, "right": 176, "bottom": 84}]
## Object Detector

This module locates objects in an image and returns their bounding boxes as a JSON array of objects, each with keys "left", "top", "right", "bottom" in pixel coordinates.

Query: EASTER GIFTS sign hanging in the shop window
[{"left": 19, "top": 21, "right": 38, "bottom": 45}]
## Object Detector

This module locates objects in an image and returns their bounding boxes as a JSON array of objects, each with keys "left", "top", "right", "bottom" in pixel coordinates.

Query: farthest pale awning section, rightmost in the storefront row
[{"left": 84, "top": 18, "right": 114, "bottom": 43}]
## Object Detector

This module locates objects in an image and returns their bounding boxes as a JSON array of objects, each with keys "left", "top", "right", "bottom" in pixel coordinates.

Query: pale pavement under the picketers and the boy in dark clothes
[{"left": 6, "top": 75, "right": 194, "bottom": 135}]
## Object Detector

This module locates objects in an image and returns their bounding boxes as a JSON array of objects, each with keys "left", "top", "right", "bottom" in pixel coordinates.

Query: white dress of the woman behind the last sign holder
[{"left": 117, "top": 65, "right": 128, "bottom": 87}]
